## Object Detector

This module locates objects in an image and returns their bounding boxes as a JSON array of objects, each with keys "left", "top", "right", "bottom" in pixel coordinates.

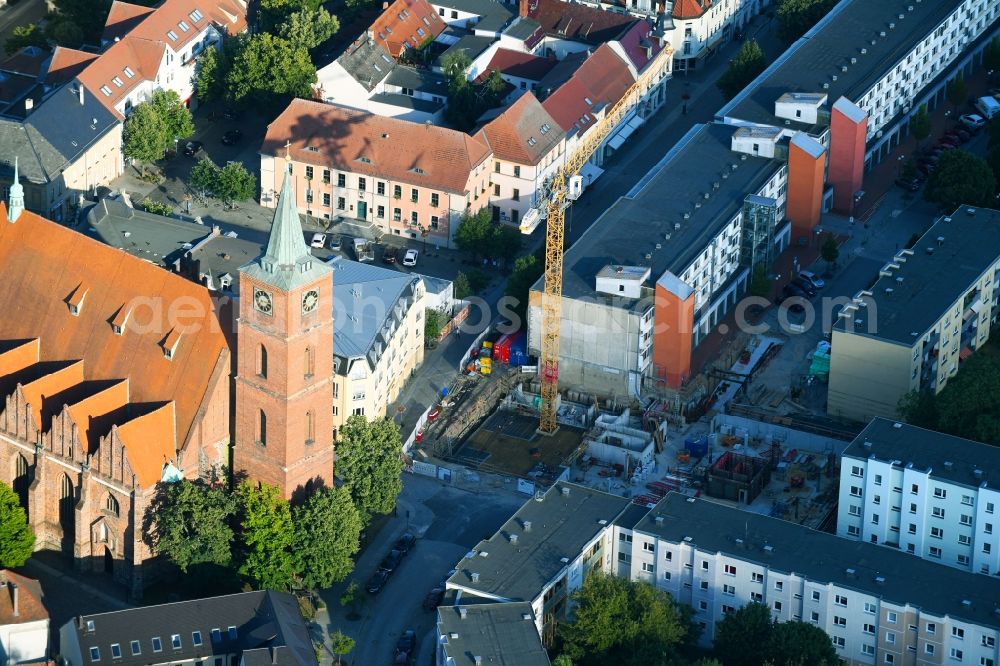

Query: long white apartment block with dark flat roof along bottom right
[{"left": 613, "top": 493, "right": 1000, "bottom": 666}]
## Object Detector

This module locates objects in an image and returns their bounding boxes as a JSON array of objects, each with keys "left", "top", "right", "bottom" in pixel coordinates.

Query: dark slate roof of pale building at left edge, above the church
[{"left": 0, "top": 85, "right": 119, "bottom": 183}]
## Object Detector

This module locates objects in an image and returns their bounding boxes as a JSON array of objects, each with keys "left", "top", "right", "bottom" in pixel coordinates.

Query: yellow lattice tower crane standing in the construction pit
[{"left": 520, "top": 45, "right": 673, "bottom": 435}]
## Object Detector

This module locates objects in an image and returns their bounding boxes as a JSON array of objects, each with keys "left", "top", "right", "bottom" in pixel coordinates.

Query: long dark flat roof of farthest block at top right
[{"left": 718, "top": 0, "right": 962, "bottom": 129}]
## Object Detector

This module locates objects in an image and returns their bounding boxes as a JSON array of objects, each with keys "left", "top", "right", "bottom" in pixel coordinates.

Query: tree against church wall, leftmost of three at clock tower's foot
[{"left": 143, "top": 480, "right": 236, "bottom": 572}]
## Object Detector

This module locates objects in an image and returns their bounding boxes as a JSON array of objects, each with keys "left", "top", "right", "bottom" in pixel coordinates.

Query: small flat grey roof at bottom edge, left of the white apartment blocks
[{"left": 438, "top": 602, "right": 551, "bottom": 666}]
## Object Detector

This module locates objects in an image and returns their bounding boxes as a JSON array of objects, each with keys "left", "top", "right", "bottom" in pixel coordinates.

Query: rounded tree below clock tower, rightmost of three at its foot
[{"left": 292, "top": 488, "right": 361, "bottom": 589}]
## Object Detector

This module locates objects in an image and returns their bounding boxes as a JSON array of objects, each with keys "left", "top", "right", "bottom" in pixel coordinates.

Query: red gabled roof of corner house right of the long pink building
[{"left": 483, "top": 92, "right": 566, "bottom": 166}]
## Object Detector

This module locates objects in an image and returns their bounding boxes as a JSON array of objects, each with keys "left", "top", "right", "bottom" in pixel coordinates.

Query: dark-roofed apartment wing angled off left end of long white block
[{"left": 446, "top": 482, "right": 631, "bottom": 645}]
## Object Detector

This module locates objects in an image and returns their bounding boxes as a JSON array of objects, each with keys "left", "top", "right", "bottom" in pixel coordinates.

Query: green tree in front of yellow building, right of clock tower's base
[{"left": 336, "top": 415, "right": 403, "bottom": 524}]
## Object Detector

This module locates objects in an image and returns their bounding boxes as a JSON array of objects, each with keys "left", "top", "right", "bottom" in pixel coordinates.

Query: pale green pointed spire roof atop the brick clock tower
[{"left": 243, "top": 171, "right": 330, "bottom": 291}]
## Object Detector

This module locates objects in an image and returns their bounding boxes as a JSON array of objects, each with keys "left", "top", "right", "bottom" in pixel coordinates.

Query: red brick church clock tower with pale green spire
[{"left": 233, "top": 158, "right": 333, "bottom": 498}]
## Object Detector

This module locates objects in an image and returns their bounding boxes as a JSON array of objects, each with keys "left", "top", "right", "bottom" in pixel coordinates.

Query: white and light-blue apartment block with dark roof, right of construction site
[{"left": 837, "top": 418, "right": 1000, "bottom": 575}]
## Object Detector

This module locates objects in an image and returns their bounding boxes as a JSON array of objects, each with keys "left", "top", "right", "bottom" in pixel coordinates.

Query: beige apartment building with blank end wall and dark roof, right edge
[{"left": 827, "top": 207, "right": 1000, "bottom": 421}]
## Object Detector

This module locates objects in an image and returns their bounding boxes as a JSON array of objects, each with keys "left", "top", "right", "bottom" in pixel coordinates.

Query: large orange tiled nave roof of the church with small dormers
[{"left": 0, "top": 203, "right": 228, "bottom": 452}]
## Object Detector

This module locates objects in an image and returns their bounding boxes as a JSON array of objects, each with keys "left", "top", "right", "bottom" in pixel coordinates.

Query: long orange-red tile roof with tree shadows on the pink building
[{"left": 260, "top": 99, "right": 490, "bottom": 194}]
